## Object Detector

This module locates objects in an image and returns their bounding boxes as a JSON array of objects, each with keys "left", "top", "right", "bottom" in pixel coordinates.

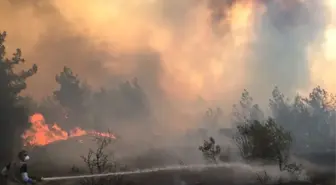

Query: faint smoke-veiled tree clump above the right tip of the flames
[{"left": 92, "top": 79, "right": 150, "bottom": 123}]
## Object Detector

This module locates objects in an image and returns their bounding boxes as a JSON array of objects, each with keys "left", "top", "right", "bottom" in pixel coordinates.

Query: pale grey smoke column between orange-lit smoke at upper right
[{"left": 252, "top": 1, "right": 325, "bottom": 100}]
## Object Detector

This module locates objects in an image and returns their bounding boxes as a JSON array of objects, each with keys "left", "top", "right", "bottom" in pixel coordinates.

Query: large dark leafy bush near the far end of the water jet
[{"left": 234, "top": 118, "right": 292, "bottom": 170}]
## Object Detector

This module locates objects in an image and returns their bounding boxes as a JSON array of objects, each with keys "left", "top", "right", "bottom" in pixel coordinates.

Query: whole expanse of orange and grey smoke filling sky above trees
[{"left": 0, "top": 0, "right": 334, "bottom": 133}]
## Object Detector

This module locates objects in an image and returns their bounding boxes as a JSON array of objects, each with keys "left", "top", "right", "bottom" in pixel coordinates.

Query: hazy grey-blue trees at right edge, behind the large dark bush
[{"left": 270, "top": 86, "right": 336, "bottom": 152}]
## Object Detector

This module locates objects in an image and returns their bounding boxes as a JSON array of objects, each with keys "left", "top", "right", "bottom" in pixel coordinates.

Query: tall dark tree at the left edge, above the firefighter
[{"left": 0, "top": 32, "right": 37, "bottom": 160}]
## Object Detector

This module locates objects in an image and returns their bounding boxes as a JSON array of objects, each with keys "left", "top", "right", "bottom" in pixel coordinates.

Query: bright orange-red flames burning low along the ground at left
[{"left": 22, "top": 113, "right": 116, "bottom": 146}]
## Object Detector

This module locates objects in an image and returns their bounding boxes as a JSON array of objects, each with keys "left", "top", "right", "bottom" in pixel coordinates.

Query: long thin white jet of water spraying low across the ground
[{"left": 43, "top": 163, "right": 255, "bottom": 181}]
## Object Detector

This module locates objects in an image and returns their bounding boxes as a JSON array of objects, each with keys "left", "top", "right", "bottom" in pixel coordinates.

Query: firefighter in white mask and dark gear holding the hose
[{"left": 1, "top": 150, "right": 42, "bottom": 185}]
